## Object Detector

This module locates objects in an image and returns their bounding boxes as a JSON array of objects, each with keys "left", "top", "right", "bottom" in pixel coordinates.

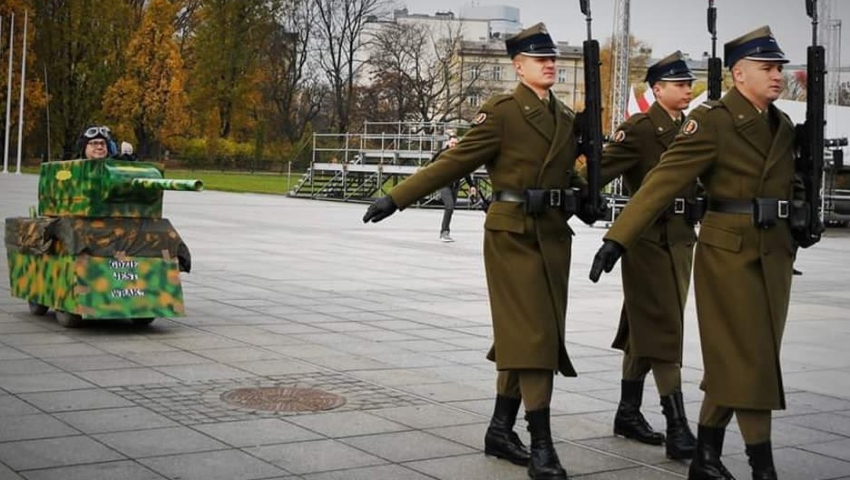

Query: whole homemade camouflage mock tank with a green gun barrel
[{"left": 5, "top": 159, "right": 203, "bottom": 327}]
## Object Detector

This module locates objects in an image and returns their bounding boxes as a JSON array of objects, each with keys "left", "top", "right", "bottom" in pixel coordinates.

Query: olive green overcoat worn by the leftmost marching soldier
[{"left": 390, "top": 84, "right": 586, "bottom": 376}]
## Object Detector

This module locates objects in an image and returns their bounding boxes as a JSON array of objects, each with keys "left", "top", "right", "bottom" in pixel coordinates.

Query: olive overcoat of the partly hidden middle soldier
[{"left": 600, "top": 102, "right": 696, "bottom": 363}]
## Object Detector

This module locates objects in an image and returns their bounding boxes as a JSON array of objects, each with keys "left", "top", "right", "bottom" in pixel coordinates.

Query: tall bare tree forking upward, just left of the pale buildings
[{"left": 312, "top": 0, "right": 385, "bottom": 132}]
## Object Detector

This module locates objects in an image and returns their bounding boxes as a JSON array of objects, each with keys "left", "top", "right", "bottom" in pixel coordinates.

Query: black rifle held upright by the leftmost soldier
[{"left": 579, "top": 0, "right": 605, "bottom": 218}]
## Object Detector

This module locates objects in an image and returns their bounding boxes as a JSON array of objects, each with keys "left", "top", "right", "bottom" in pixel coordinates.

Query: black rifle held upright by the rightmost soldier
[{"left": 795, "top": 0, "right": 826, "bottom": 247}]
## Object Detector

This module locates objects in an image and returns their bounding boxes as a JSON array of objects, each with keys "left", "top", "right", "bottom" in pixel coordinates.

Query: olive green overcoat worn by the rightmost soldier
[{"left": 606, "top": 88, "right": 799, "bottom": 409}]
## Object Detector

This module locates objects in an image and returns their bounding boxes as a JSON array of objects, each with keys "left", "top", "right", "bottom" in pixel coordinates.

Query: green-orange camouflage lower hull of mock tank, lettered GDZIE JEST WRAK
[{"left": 7, "top": 250, "right": 184, "bottom": 319}]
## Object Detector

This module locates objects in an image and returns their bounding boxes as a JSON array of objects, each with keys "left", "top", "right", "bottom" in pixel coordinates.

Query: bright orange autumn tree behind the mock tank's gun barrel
[{"left": 103, "top": 0, "right": 189, "bottom": 156}]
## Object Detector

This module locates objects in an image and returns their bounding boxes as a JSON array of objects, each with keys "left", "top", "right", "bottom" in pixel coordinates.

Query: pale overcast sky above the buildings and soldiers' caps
[{"left": 396, "top": 0, "right": 850, "bottom": 68}]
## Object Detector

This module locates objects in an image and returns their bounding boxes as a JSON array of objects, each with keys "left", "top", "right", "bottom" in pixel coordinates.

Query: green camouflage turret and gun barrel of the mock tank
[{"left": 38, "top": 159, "right": 203, "bottom": 218}]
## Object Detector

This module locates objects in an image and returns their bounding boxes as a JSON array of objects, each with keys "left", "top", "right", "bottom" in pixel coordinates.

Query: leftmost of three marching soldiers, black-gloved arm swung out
[{"left": 363, "top": 23, "right": 592, "bottom": 480}]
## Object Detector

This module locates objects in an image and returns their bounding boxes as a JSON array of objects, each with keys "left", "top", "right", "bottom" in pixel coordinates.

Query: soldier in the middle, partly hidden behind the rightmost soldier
[{"left": 588, "top": 51, "right": 698, "bottom": 459}]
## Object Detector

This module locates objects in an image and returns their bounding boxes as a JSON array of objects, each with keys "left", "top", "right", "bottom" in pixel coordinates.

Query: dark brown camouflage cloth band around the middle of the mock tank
[{"left": 5, "top": 217, "right": 192, "bottom": 272}]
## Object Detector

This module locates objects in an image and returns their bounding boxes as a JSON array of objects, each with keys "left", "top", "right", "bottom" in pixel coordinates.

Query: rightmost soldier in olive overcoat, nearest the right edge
[{"left": 590, "top": 27, "right": 820, "bottom": 480}]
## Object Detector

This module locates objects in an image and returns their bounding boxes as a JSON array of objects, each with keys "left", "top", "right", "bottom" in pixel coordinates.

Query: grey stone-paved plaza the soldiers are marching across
[{"left": 0, "top": 174, "right": 850, "bottom": 480}]
